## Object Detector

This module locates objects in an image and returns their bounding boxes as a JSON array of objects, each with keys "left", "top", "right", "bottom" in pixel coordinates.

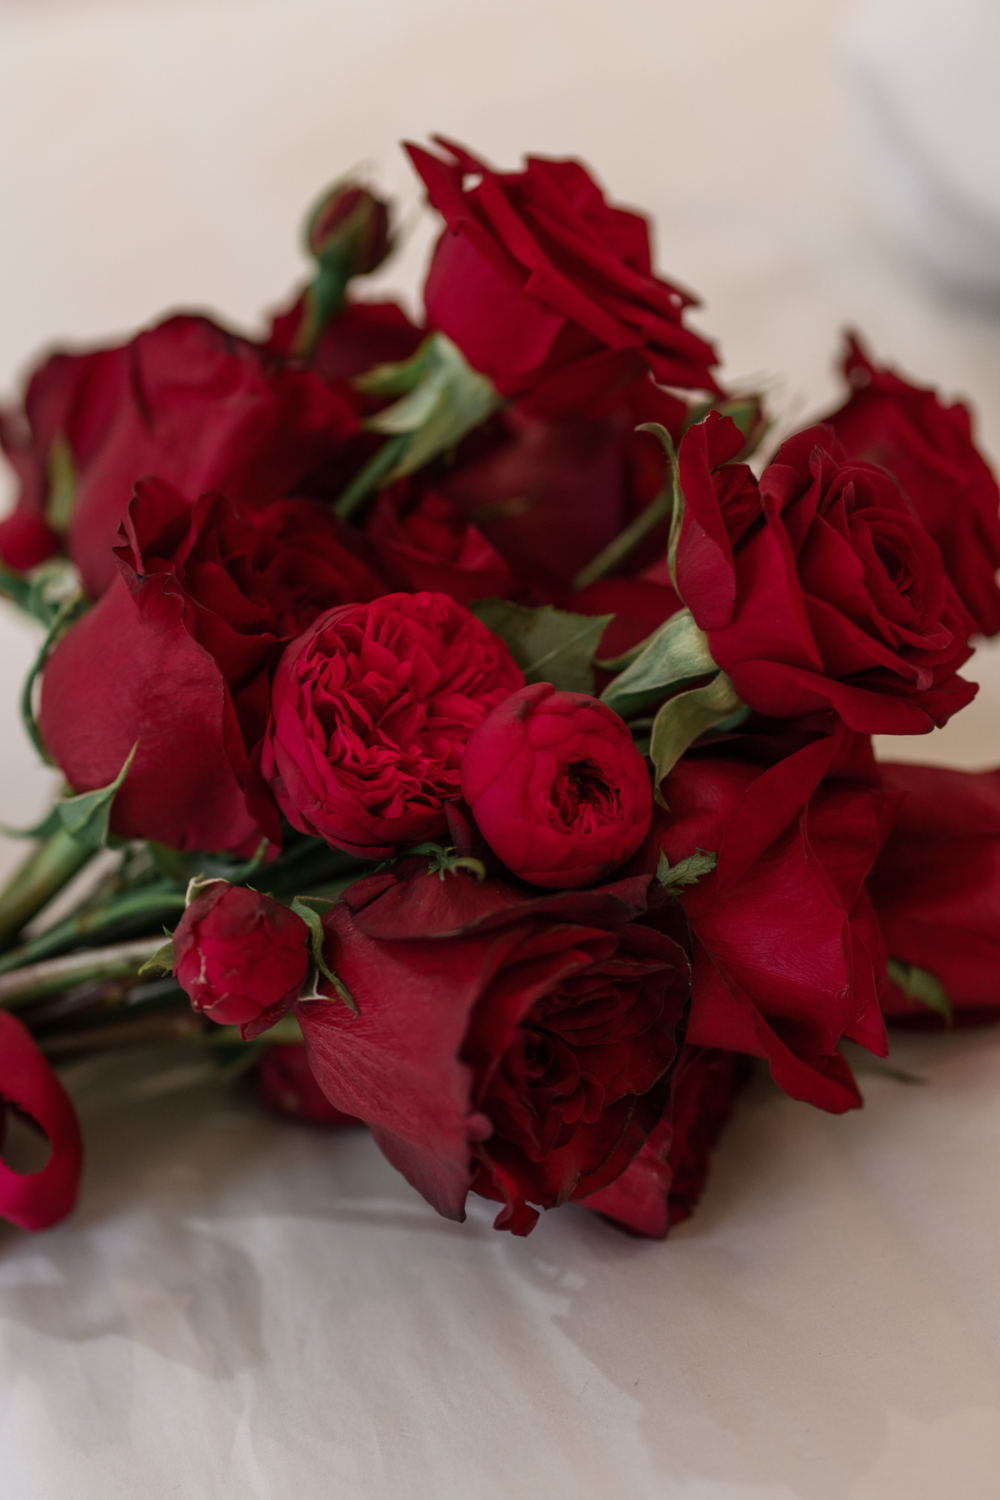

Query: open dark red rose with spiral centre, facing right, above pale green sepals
[{"left": 676, "top": 416, "right": 976, "bottom": 735}]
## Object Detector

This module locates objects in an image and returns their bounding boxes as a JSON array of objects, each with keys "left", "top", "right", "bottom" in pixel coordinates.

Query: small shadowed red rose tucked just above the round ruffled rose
[{"left": 364, "top": 480, "right": 517, "bottom": 605}]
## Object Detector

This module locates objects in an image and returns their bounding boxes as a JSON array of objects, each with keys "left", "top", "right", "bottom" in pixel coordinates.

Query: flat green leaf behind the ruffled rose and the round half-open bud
[{"left": 471, "top": 599, "right": 615, "bottom": 693}]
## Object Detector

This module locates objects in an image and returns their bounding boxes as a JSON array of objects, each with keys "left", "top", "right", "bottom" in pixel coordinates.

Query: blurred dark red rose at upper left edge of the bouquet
[{"left": 0, "top": 317, "right": 358, "bottom": 599}]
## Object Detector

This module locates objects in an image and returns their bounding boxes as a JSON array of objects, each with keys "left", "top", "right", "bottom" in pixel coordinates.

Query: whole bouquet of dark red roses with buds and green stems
[{"left": 0, "top": 141, "right": 1000, "bottom": 1236}]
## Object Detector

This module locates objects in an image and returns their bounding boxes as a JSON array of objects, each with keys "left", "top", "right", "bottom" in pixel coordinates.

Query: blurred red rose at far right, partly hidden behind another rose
[{"left": 826, "top": 338, "right": 1000, "bottom": 636}]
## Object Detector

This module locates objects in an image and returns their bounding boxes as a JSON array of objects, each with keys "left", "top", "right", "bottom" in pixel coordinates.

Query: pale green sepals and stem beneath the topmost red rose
[{"left": 334, "top": 333, "right": 504, "bottom": 521}]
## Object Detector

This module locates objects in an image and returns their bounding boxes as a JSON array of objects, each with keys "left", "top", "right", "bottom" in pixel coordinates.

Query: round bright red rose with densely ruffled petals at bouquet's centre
[{"left": 261, "top": 594, "right": 523, "bottom": 860}]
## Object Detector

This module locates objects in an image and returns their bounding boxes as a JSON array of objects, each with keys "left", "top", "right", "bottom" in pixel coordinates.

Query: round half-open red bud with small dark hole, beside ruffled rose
[{"left": 462, "top": 683, "right": 652, "bottom": 888}]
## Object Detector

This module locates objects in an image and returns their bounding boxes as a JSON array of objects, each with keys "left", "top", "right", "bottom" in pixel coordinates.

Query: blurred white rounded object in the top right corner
[{"left": 847, "top": 0, "right": 1000, "bottom": 300}]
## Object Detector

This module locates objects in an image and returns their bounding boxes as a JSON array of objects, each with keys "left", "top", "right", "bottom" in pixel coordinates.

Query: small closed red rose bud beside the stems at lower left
[{"left": 174, "top": 881, "right": 309, "bottom": 1041}]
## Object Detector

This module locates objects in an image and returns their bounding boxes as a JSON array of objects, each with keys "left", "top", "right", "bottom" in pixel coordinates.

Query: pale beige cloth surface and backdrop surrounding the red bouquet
[{"left": 0, "top": 0, "right": 1000, "bottom": 1500}]
